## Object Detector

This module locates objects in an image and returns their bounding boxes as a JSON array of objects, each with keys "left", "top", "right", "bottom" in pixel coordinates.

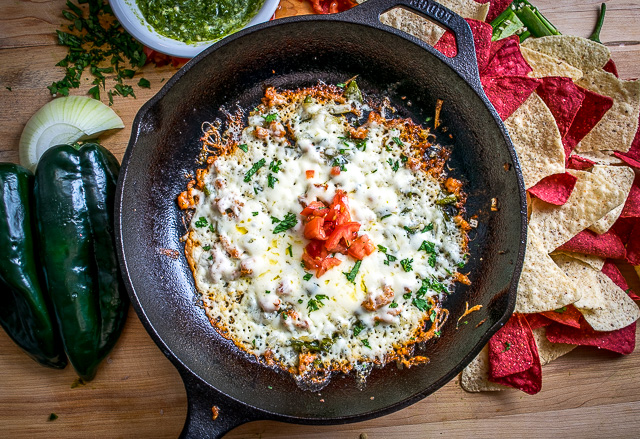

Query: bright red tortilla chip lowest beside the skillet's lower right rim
[{"left": 489, "top": 314, "right": 533, "bottom": 379}]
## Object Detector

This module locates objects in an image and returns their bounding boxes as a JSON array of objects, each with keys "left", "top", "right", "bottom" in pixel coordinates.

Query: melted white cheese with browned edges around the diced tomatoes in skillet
[{"left": 180, "top": 83, "right": 467, "bottom": 389}]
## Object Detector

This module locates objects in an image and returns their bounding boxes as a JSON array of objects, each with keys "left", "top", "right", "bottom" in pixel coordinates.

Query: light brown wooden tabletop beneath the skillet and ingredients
[{"left": 0, "top": 0, "right": 640, "bottom": 439}]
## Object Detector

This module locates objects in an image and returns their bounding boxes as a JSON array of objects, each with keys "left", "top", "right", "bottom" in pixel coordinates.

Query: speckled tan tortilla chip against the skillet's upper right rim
[{"left": 505, "top": 93, "right": 565, "bottom": 189}]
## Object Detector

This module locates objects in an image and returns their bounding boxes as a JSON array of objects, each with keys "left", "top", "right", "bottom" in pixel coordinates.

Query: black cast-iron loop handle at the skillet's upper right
[{"left": 339, "top": 0, "right": 480, "bottom": 85}]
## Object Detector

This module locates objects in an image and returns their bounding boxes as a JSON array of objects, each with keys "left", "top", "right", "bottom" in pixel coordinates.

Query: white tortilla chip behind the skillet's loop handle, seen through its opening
[{"left": 378, "top": 0, "right": 490, "bottom": 46}]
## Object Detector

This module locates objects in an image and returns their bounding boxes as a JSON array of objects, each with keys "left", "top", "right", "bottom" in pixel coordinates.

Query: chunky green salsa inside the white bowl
[{"left": 137, "top": 0, "right": 265, "bottom": 43}]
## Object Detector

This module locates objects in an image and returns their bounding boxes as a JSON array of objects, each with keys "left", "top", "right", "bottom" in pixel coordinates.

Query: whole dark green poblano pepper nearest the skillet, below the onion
[{"left": 34, "top": 144, "right": 129, "bottom": 381}]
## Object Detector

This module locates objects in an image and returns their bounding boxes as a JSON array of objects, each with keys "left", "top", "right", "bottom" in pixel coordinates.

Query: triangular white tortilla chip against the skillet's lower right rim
[{"left": 515, "top": 231, "right": 581, "bottom": 314}]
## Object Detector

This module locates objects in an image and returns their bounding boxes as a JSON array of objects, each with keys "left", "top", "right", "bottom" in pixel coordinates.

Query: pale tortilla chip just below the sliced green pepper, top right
[{"left": 522, "top": 35, "right": 611, "bottom": 72}]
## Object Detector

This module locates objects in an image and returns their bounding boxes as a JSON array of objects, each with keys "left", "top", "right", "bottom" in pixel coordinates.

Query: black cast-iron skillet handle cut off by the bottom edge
[{"left": 180, "top": 370, "right": 262, "bottom": 439}]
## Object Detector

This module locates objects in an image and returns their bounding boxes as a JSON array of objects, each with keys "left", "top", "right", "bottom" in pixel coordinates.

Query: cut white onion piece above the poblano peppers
[{"left": 20, "top": 96, "right": 124, "bottom": 171}]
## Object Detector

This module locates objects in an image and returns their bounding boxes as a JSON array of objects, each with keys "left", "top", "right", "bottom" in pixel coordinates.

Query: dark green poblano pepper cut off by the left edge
[{"left": 0, "top": 163, "right": 67, "bottom": 369}]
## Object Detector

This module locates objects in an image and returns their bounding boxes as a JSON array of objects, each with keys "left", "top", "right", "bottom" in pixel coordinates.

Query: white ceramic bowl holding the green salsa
[{"left": 109, "top": 0, "right": 279, "bottom": 58}]
